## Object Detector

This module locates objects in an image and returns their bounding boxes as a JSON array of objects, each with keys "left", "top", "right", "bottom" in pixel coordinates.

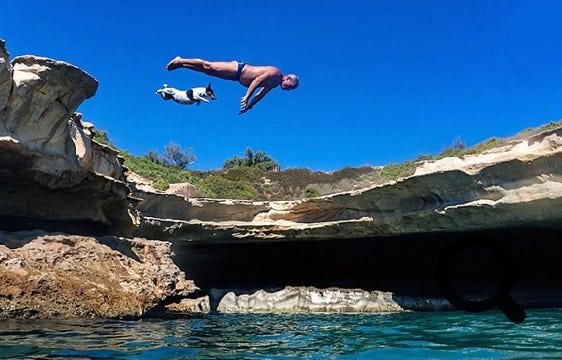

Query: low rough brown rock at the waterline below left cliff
[{"left": 0, "top": 232, "right": 195, "bottom": 318}]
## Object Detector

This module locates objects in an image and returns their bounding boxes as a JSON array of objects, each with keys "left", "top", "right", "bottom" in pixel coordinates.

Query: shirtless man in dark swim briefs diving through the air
[{"left": 166, "top": 56, "right": 299, "bottom": 114}]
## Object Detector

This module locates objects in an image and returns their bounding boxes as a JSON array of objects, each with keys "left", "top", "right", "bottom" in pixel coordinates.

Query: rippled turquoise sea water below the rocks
[{"left": 0, "top": 310, "right": 562, "bottom": 359}]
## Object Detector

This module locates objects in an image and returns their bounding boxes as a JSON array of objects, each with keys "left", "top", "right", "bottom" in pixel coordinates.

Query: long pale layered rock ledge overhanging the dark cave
[{"left": 133, "top": 129, "right": 562, "bottom": 242}]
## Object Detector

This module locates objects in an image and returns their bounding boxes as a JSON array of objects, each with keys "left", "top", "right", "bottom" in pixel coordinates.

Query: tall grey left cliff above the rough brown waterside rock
[{"left": 0, "top": 41, "right": 133, "bottom": 234}]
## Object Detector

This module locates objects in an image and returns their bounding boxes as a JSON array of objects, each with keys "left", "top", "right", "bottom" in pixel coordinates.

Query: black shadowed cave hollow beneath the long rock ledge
[{"left": 173, "top": 228, "right": 562, "bottom": 306}]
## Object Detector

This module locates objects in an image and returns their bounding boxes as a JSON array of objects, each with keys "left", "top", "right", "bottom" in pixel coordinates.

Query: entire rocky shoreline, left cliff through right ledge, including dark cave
[{"left": 0, "top": 40, "right": 562, "bottom": 318}]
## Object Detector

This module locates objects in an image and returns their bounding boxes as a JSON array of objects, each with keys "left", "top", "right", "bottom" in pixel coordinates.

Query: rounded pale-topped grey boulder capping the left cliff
[{"left": 1, "top": 56, "right": 98, "bottom": 158}]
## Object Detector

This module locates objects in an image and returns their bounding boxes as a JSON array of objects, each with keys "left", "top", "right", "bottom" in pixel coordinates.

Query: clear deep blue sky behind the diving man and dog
[{"left": 0, "top": 0, "right": 562, "bottom": 171}]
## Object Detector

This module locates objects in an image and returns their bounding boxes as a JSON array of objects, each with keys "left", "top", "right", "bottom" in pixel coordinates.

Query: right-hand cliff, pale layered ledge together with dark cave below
[{"left": 135, "top": 121, "right": 562, "bottom": 311}]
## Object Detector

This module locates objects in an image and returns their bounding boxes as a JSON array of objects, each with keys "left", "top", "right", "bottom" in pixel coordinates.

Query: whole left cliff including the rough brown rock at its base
[{"left": 0, "top": 40, "right": 196, "bottom": 318}]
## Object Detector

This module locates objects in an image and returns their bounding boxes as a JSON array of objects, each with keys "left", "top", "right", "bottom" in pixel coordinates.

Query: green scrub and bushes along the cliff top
[{"left": 94, "top": 121, "right": 562, "bottom": 200}]
